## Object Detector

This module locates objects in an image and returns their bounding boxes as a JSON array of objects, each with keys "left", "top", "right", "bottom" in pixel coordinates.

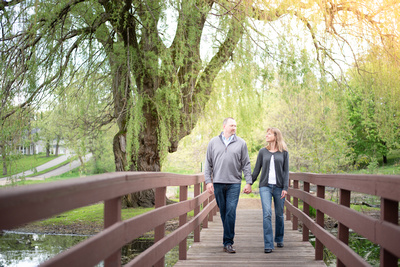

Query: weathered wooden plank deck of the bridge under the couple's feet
[{"left": 174, "top": 202, "right": 326, "bottom": 267}]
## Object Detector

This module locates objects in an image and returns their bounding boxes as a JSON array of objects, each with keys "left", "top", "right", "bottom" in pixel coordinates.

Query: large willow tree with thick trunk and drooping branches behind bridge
[{"left": 0, "top": 0, "right": 397, "bottom": 205}]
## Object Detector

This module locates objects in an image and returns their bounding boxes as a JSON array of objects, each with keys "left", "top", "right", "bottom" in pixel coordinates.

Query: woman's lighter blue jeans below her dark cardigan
[{"left": 260, "top": 184, "right": 285, "bottom": 249}]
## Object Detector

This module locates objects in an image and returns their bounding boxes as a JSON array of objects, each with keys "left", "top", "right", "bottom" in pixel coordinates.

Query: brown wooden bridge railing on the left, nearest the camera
[{"left": 0, "top": 172, "right": 217, "bottom": 267}]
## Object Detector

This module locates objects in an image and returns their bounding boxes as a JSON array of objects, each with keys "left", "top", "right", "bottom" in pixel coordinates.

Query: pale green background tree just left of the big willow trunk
[{"left": 45, "top": 72, "right": 115, "bottom": 174}]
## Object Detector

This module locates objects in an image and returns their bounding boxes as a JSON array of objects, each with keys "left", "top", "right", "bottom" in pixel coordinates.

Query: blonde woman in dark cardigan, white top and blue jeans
[{"left": 252, "top": 127, "right": 289, "bottom": 253}]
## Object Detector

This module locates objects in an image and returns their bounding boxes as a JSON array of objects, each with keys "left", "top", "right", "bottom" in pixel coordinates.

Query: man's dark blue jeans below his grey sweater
[{"left": 214, "top": 183, "right": 241, "bottom": 246}]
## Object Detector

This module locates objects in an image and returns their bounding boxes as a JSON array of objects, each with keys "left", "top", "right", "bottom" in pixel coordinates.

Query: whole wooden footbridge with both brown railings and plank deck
[{"left": 0, "top": 172, "right": 400, "bottom": 267}]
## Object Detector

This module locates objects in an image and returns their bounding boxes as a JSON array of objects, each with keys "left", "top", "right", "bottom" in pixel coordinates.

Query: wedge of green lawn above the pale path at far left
[{"left": 0, "top": 153, "right": 57, "bottom": 178}]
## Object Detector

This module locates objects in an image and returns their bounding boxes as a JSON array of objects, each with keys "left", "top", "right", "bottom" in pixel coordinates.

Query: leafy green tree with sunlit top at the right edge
[{"left": 347, "top": 44, "right": 400, "bottom": 168}]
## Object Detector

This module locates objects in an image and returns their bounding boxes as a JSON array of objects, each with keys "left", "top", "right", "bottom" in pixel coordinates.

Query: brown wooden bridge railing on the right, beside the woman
[{"left": 286, "top": 173, "right": 400, "bottom": 267}]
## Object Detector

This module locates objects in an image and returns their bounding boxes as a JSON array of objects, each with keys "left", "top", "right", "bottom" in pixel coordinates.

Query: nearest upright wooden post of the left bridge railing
[{"left": 104, "top": 197, "right": 121, "bottom": 267}]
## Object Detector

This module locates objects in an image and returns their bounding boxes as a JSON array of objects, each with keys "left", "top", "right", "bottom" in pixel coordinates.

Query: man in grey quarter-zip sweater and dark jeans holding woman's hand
[{"left": 204, "top": 117, "right": 252, "bottom": 253}]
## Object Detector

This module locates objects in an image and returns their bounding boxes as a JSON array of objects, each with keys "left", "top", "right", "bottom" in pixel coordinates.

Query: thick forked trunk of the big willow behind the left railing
[{"left": 110, "top": 1, "right": 243, "bottom": 207}]
